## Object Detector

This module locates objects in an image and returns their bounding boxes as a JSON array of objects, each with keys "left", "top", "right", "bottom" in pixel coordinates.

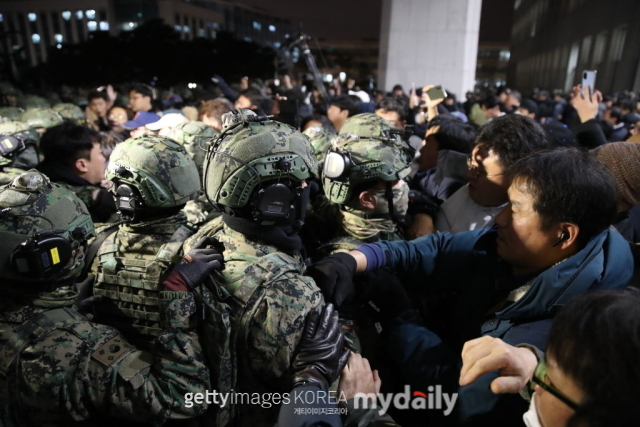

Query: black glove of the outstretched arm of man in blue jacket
[{"left": 307, "top": 252, "right": 357, "bottom": 307}]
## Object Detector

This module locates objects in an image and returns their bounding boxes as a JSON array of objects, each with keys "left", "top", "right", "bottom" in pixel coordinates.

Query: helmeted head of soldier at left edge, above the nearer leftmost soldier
[{"left": 0, "top": 122, "right": 40, "bottom": 185}]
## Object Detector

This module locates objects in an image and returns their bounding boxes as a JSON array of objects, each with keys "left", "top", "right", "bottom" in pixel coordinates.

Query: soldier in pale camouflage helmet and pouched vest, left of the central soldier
[{"left": 91, "top": 136, "right": 200, "bottom": 348}]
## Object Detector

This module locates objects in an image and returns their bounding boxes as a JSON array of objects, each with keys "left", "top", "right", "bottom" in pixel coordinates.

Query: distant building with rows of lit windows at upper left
[{"left": 0, "top": 0, "right": 295, "bottom": 66}]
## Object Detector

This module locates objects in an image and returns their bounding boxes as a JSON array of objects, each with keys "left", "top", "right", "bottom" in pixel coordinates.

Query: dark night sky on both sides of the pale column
[{"left": 232, "top": 0, "right": 514, "bottom": 41}]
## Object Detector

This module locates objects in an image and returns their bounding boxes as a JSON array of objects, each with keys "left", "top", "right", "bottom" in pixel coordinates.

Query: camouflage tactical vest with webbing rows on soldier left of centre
[{"left": 93, "top": 226, "right": 193, "bottom": 350}]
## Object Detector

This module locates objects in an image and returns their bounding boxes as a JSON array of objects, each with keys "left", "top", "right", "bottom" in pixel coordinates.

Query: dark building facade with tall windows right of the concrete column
[{"left": 507, "top": 0, "right": 640, "bottom": 93}]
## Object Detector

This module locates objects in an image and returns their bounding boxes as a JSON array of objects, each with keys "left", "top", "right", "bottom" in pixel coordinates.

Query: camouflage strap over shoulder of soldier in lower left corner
[{"left": 0, "top": 307, "right": 87, "bottom": 378}]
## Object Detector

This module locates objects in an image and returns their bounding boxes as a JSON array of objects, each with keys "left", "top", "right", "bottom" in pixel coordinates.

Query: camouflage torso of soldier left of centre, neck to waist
[{"left": 91, "top": 214, "right": 191, "bottom": 348}]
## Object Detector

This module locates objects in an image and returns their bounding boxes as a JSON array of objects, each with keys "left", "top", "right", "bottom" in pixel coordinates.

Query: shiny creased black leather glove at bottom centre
[{"left": 293, "top": 304, "right": 350, "bottom": 390}]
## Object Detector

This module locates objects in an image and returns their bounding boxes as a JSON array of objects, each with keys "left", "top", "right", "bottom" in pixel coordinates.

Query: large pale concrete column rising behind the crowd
[{"left": 378, "top": 0, "right": 482, "bottom": 99}]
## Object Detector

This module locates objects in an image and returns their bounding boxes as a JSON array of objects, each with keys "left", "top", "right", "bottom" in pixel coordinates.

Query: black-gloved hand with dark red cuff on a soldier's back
[{"left": 163, "top": 237, "right": 224, "bottom": 291}]
